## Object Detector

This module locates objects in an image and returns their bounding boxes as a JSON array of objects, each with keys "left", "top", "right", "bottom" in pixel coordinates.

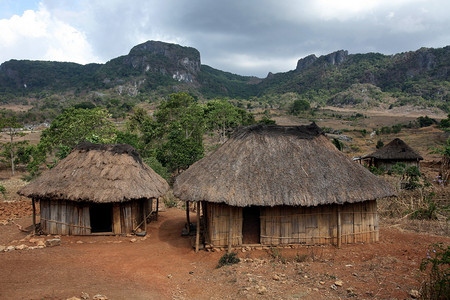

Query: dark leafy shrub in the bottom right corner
[{"left": 420, "top": 243, "right": 450, "bottom": 300}]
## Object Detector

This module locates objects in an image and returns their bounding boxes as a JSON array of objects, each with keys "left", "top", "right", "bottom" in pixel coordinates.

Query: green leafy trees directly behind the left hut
[{"left": 0, "top": 92, "right": 273, "bottom": 178}]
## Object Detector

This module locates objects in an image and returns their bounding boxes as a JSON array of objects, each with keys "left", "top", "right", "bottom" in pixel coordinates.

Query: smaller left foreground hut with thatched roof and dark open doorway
[{"left": 19, "top": 143, "right": 169, "bottom": 235}]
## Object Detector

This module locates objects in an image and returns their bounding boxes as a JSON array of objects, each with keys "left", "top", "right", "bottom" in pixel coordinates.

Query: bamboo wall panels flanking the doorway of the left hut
[{"left": 40, "top": 200, "right": 151, "bottom": 235}]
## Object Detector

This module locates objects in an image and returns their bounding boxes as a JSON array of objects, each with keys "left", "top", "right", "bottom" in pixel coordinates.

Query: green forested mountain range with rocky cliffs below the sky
[{"left": 0, "top": 41, "right": 450, "bottom": 122}]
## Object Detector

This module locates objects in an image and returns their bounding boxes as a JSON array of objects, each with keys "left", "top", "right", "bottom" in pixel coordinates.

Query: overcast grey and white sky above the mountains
[{"left": 0, "top": 0, "right": 450, "bottom": 77}]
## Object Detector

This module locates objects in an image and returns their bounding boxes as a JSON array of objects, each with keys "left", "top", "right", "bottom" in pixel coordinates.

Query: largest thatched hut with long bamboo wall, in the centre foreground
[{"left": 174, "top": 123, "right": 395, "bottom": 249}]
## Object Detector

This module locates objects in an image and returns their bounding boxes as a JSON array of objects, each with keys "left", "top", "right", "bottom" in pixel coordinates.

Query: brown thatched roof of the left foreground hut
[{"left": 19, "top": 143, "right": 169, "bottom": 203}]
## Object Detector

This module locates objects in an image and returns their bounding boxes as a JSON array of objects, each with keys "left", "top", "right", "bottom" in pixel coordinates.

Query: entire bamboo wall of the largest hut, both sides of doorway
[{"left": 206, "top": 200, "right": 379, "bottom": 246}]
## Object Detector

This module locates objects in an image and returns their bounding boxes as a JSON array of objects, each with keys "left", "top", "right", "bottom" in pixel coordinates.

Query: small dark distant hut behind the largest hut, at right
[{"left": 361, "top": 138, "right": 423, "bottom": 170}]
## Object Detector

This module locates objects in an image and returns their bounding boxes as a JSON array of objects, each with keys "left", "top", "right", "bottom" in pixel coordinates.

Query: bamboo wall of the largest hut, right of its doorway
[{"left": 260, "top": 201, "right": 378, "bottom": 245}]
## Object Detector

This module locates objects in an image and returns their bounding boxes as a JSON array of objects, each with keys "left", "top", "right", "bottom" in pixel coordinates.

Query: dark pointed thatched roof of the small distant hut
[{"left": 361, "top": 138, "right": 423, "bottom": 160}]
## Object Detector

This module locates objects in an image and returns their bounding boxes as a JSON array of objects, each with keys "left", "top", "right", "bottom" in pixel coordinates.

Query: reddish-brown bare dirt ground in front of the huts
[{"left": 0, "top": 201, "right": 450, "bottom": 299}]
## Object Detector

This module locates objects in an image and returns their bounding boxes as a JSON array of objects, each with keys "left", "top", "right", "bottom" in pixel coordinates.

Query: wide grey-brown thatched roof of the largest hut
[{"left": 174, "top": 123, "right": 395, "bottom": 207}]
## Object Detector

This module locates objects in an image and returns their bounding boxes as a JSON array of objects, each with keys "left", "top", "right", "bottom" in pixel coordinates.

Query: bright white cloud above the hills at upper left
[{"left": 0, "top": 5, "right": 98, "bottom": 64}]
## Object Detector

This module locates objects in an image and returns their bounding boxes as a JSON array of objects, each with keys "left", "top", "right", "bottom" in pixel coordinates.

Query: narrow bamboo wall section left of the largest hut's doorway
[{"left": 206, "top": 203, "right": 242, "bottom": 246}]
